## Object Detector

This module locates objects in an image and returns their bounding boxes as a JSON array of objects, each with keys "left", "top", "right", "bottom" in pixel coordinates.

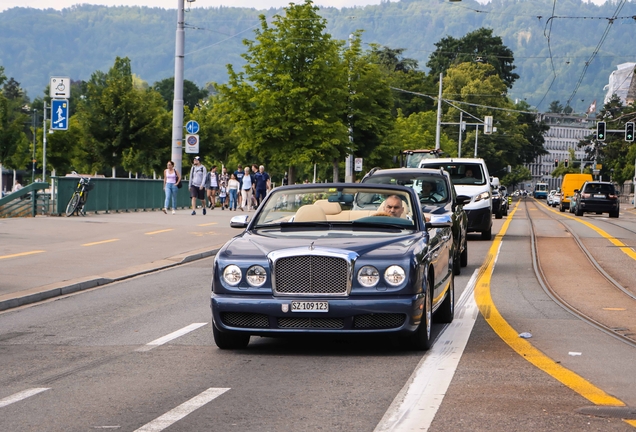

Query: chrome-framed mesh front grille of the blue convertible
[{"left": 273, "top": 255, "right": 350, "bottom": 296}]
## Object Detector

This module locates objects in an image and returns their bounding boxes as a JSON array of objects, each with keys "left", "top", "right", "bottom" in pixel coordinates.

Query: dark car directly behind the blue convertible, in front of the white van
[{"left": 362, "top": 168, "right": 470, "bottom": 275}]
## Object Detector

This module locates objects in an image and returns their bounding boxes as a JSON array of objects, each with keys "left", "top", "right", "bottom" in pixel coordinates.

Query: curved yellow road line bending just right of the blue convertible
[{"left": 475, "top": 204, "right": 636, "bottom": 412}]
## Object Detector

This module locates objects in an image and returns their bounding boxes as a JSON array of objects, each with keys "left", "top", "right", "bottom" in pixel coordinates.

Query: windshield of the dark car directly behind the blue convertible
[{"left": 365, "top": 174, "right": 450, "bottom": 206}]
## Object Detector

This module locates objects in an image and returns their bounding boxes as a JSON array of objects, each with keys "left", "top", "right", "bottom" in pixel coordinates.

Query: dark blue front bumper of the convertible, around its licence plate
[{"left": 211, "top": 294, "right": 424, "bottom": 336}]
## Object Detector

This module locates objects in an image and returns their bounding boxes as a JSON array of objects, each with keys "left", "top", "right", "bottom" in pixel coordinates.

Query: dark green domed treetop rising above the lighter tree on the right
[{"left": 426, "top": 27, "right": 519, "bottom": 88}]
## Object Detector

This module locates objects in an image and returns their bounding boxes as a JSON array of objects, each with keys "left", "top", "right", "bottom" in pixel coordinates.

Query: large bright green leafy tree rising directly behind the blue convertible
[{"left": 219, "top": 0, "right": 348, "bottom": 182}]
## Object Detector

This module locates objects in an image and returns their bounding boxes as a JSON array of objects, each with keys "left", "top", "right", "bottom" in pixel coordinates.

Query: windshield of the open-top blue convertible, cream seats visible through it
[{"left": 254, "top": 184, "right": 415, "bottom": 229}]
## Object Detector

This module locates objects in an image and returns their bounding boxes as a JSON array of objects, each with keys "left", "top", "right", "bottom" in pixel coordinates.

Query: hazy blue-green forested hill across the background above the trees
[{"left": 0, "top": 0, "right": 636, "bottom": 112}]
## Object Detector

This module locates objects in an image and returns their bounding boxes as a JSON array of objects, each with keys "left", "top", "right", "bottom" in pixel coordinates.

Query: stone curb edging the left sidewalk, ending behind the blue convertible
[{"left": 0, "top": 248, "right": 220, "bottom": 312}]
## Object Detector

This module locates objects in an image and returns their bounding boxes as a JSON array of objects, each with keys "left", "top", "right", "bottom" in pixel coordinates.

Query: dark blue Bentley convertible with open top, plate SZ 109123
[{"left": 211, "top": 183, "right": 455, "bottom": 350}]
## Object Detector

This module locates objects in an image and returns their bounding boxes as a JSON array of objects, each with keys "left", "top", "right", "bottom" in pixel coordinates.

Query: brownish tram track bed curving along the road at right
[{"left": 522, "top": 200, "right": 636, "bottom": 348}]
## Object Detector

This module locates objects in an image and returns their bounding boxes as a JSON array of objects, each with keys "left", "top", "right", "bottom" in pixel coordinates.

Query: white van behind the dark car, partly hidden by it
[{"left": 420, "top": 158, "right": 492, "bottom": 240}]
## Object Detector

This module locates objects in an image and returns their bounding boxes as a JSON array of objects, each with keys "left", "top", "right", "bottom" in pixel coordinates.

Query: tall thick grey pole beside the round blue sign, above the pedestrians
[{"left": 171, "top": 0, "right": 186, "bottom": 174}]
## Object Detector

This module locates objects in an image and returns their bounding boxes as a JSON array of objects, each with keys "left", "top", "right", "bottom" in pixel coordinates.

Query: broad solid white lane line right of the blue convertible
[{"left": 375, "top": 269, "right": 479, "bottom": 432}]
